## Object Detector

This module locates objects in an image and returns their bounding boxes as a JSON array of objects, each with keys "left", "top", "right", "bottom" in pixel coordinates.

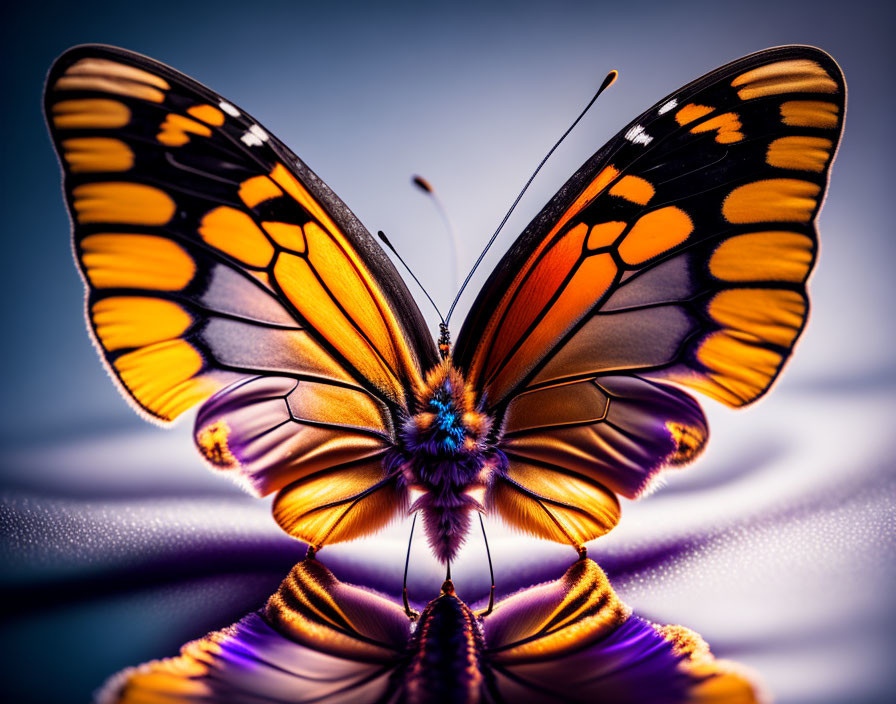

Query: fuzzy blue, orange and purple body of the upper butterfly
[{"left": 388, "top": 360, "right": 507, "bottom": 562}]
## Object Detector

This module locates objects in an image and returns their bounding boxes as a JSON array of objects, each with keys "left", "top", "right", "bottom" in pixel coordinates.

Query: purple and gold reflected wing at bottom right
[{"left": 483, "top": 560, "right": 760, "bottom": 704}]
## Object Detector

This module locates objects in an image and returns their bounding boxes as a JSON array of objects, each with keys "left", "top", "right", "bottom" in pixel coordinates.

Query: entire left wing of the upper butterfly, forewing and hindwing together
[{"left": 45, "top": 46, "right": 437, "bottom": 544}]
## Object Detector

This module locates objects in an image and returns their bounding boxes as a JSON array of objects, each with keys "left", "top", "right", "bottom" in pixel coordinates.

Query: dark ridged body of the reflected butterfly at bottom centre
[{"left": 405, "top": 582, "right": 483, "bottom": 704}]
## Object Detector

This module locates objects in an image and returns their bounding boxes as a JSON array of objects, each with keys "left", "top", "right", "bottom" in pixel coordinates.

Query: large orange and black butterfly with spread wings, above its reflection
[{"left": 45, "top": 46, "right": 846, "bottom": 564}]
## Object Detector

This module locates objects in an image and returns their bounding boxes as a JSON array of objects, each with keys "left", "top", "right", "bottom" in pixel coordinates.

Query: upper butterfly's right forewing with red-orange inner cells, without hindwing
[{"left": 454, "top": 47, "right": 845, "bottom": 407}]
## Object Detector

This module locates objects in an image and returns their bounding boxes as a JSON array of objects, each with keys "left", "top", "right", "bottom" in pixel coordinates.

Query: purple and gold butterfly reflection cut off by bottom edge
[{"left": 99, "top": 558, "right": 760, "bottom": 704}]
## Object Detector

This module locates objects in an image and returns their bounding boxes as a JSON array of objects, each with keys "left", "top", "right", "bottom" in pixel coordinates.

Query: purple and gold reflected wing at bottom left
[{"left": 99, "top": 560, "right": 408, "bottom": 704}]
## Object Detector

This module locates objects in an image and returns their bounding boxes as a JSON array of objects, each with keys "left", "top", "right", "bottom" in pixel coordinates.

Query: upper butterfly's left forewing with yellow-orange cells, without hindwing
[{"left": 45, "top": 46, "right": 436, "bottom": 421}]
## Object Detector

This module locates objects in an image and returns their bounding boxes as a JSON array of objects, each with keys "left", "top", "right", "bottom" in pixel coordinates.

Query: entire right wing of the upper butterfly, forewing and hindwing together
[{"left": 454, "top": 46, "right": 846, "bottom": 544}]
